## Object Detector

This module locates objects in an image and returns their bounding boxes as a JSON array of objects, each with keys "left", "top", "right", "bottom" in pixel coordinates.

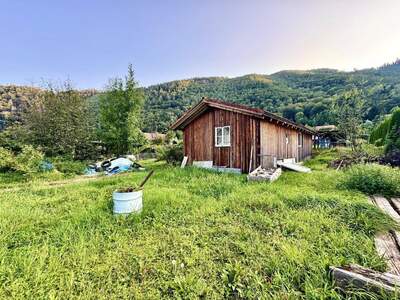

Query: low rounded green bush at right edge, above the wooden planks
[{"left": 340, "top": 164, "right": 400, "bottom": 196}]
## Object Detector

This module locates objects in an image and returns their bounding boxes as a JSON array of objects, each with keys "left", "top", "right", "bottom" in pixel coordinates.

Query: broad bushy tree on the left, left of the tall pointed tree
[{"left": 23, "top": 82, "right": 95, "bottom": 159}]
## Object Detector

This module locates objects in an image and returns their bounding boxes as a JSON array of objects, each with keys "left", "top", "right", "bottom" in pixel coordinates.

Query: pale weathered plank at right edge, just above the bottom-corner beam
[{"left": 375, "top": 233, "right": 400, "bottom": 275}]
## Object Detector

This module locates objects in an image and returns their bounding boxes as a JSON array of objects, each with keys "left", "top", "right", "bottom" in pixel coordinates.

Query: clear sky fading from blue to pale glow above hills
[{"left": 0, "top": 0, "right": 400, "bottom": 89}]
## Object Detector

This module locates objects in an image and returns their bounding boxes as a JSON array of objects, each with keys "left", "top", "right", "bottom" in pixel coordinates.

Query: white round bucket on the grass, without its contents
[{"left": 113, "top": 190, "right": 143, "bottom": 214}]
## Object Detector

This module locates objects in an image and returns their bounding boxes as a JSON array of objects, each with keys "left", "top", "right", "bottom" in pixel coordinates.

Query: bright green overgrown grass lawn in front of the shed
[{"left": 0, "top": 152, "right": 391, "bottom": 299}]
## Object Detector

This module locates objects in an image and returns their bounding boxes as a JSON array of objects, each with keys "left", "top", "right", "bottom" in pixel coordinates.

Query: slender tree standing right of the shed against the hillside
[{"left": 334, "top": 89, "right": 364, "bottom": 150}]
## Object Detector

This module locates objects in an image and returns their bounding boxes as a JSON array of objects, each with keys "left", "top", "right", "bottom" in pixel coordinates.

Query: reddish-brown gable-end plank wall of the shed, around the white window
[{"left": 184, "top": 109, "right": 260, "bottom": 172}]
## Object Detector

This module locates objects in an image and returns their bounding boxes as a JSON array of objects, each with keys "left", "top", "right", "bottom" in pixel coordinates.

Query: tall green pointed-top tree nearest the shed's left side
[{"left": 99, "top": 64, "right": 145, "bottom": 155}]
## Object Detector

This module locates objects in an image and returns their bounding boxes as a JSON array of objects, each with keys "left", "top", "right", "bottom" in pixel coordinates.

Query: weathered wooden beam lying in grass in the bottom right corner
[{"left": 329, "top": 265, "right": 400, "bottom": 296}]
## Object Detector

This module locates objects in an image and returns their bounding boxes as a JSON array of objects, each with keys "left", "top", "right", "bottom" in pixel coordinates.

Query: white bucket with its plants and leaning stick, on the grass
[{"left": 113, "top": 170, "right": 154, "bottom": 215}]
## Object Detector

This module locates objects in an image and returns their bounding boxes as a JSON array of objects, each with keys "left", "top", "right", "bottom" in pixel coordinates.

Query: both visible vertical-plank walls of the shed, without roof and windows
[{"left": 184, "top": 109, "right": 312, "bottom": 173}]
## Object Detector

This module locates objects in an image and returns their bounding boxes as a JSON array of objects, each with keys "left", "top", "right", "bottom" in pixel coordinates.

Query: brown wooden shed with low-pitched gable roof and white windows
[{"left": 171, "top": 98, "right": 314, "bottom": 173}]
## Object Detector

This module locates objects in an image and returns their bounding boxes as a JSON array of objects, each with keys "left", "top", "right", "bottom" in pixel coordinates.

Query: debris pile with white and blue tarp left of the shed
[{"left": 85, "top": 155, "right": 144, "bottom": 176}]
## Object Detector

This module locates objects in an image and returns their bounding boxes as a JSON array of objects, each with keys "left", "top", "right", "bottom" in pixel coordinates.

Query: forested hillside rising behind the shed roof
[{"left": 144, "top": 61, "right": 400, "bottom": 131}]
